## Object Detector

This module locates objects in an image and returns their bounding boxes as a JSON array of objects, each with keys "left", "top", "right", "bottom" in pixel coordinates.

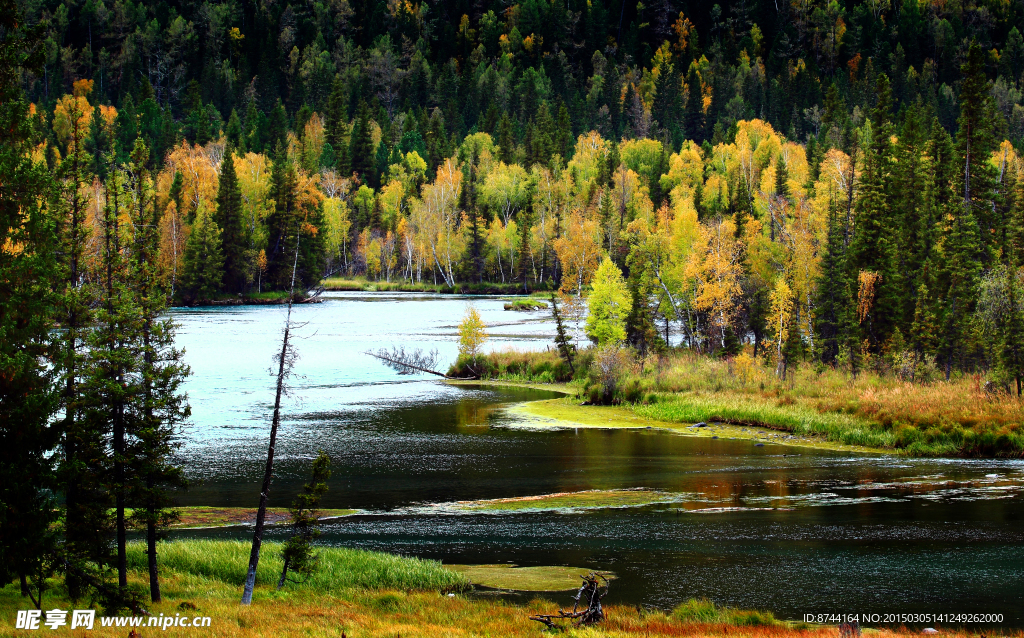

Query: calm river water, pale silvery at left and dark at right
[{"left": 163, "top": 293, "right": 1024, "bottom": 627}]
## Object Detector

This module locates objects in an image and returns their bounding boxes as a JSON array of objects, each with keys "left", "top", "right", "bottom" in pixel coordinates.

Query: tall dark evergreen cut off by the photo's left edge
[{"left": 0, "top": 11, "right": 62, "bottom": 610}]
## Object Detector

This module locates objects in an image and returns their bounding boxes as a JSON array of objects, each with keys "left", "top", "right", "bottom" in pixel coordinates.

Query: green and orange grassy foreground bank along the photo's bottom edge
[{"left": 0, "top": 541, "right": 995, "bottom": 638}]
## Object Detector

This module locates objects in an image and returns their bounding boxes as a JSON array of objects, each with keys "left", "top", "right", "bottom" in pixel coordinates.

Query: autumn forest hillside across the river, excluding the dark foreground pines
[{"left": 10, "top": 0, "right": 1024, "bottom": 374}]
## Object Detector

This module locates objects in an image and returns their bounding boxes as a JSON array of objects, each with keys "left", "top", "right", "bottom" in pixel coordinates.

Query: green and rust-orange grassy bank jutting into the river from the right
[{"left": 462, "top": 350, "right": 1024, "bottom": 458}]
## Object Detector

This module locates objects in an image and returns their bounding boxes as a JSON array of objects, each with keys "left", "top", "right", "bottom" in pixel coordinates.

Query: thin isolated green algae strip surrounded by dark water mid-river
[{"left": 455, "top": 490, "right": 685, "bottom": 512}]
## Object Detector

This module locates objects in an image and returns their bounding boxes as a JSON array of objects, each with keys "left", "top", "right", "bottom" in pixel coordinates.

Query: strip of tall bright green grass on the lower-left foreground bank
[{"left": 128, "top": 541, "right": 469, "bottom": 592}]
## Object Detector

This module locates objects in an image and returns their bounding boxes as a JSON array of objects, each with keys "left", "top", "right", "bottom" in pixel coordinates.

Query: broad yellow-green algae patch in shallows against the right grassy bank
[{"left": 508, "top": 394, "right": 893, "bottom": 454}]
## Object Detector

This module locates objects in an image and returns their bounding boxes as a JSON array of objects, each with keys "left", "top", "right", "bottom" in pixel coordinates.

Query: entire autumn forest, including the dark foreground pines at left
[{"left": 6, "top": 0, "right": 1024, "bottom": 618}]
